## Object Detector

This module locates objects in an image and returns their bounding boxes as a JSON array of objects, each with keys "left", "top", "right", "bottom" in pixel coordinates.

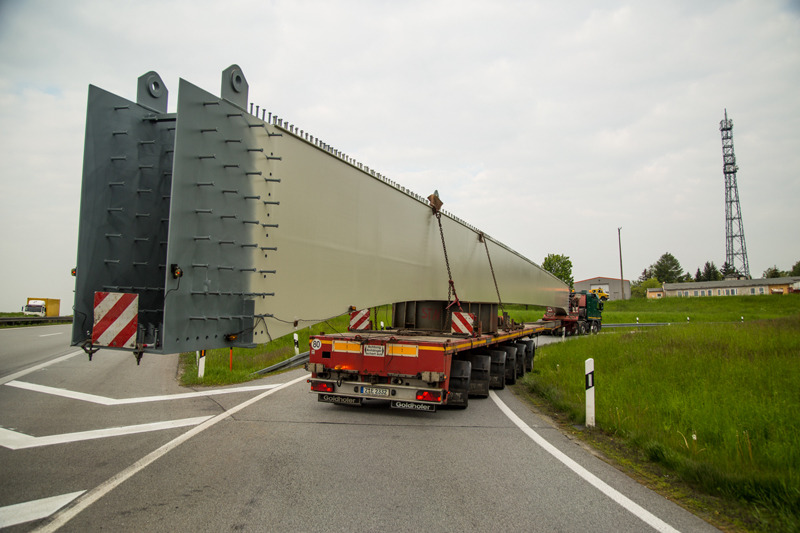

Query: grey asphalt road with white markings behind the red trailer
[{"left": 0, "top": 326, "right": 715, "bottom": 532}]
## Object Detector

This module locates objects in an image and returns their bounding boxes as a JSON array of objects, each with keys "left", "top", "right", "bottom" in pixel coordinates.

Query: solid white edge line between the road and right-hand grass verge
[{"left": 489, "top": 391, "right": 678, "bottom": 533}]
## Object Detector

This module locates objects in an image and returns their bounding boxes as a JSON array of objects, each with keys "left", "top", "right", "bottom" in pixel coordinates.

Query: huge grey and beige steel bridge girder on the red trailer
[{"left": 72, "top": 65, "right": 568, "bottom": 353}]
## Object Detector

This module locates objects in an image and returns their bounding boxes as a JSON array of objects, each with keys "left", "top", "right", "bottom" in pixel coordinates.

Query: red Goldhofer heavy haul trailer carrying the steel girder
[{"left": 306, "top": 301, "right": 559, "bottom": 411}]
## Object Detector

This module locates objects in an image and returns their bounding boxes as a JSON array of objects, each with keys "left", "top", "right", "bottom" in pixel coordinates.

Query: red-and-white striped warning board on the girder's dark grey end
[{"left": 92, "top": 292, "right": 139, "bottom": 348}]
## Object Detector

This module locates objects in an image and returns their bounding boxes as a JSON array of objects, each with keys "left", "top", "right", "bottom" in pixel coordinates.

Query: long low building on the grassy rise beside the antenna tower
[{"left": 664, "top": 276, "right": 800, "bottom": 298}]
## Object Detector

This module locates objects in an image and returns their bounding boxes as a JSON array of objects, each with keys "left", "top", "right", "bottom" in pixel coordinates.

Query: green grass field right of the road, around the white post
[{"left": 523, "top": 314, "right": 800, "bottom": 531}]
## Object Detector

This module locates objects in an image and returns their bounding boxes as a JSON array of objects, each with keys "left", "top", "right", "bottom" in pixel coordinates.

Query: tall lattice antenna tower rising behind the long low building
[{"left": 719, "top": 109, "right": 750, "bottom": 279}]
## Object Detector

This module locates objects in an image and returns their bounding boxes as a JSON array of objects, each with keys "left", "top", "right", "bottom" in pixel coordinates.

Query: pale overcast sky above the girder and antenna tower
[{"left": 0, "top": 0, "right": 800, "bottom": 314}]
